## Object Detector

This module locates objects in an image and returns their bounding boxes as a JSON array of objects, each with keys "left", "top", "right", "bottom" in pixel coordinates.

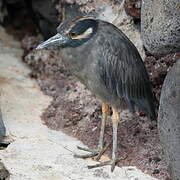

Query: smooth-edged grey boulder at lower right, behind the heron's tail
[{"left": 158, "top": 58, "right": 180, "bottom": 180}]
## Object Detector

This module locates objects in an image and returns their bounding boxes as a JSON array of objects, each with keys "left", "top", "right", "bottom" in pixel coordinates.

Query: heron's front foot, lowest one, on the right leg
[{"left": 87, "top": 156, "right": 127, "bottom": 172}]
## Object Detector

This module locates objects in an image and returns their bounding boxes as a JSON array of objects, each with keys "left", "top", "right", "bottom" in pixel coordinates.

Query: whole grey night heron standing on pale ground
[{"left": 37, "top": 17, "right": 156, "bottom": 171}]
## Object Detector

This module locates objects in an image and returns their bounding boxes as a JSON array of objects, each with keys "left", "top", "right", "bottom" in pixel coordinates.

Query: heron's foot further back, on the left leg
[{"left": 74, "top": 143, "right": 111, "bottom": 161}]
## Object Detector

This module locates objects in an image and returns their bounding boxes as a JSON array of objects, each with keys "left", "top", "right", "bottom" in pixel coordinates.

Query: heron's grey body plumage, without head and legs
[{"left": 59, "top": 20, "right": 156, "bottom": 120}]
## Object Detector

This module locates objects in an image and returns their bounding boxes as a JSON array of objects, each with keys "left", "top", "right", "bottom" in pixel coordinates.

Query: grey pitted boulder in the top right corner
[{"left": 141, "top": 0, "right": 180, "bottom": 56}]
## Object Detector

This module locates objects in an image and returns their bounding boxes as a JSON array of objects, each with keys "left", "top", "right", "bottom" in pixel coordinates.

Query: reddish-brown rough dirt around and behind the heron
[{"left": 20, "top": 37, "right": 179, "bottom": 180}]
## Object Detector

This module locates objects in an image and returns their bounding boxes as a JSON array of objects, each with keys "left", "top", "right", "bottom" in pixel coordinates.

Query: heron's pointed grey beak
[{"left": 36, "top": 33, "right": 68, "bottom": 49}]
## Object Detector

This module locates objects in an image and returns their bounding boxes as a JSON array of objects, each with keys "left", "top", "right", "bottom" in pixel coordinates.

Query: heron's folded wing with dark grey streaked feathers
[{"left": 97, "top": 25, "right": 155, "bottom": 119}]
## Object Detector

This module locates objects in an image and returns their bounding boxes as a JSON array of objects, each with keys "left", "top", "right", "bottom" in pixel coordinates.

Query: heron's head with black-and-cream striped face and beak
[{"left": 36, "top": 17, "right": 98, "bottom": 49}]
